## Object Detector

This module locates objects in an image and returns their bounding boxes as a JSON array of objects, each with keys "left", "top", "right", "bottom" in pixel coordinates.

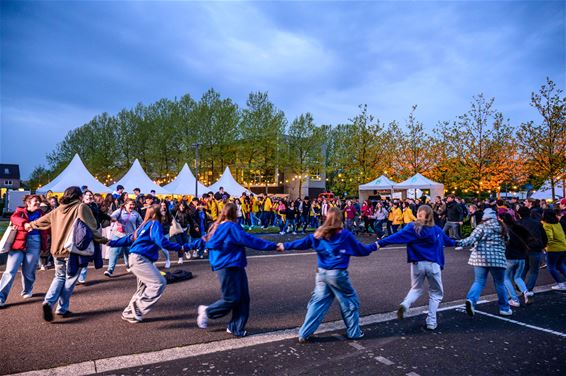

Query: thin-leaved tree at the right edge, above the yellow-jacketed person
[{"left": 517, "top": 78, "right": 566, "bottom": 199}]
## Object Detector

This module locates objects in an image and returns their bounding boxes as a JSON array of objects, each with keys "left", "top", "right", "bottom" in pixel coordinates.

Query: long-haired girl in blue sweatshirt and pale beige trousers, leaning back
[{"left": 108, "top": 205, "right": 196, "bottom": 323}]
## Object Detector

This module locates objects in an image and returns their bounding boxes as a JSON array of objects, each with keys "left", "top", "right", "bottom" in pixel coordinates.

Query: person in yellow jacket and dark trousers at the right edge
[{"left": 542, "top": 209, "right": 566, "bottom": 291}]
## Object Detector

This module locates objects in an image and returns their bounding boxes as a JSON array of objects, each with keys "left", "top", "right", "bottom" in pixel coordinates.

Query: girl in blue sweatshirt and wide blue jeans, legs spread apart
[{"left": 278, "top": 207, "right": 377, "bottom": 343}]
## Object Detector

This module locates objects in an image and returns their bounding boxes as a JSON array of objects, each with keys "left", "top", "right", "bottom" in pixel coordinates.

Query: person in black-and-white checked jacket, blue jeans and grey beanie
[{"left": 458, "top": 208, "right": 513, "bottom": 316}]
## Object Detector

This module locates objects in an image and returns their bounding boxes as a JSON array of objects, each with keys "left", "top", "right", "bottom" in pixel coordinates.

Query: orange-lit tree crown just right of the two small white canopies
[{"left": 439, "top": 94, "right": 513, "bottom": 192}]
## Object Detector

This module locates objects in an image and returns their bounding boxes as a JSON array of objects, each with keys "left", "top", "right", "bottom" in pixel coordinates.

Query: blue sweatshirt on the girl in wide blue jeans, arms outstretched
[{"left": 284, "top": 230, "right": 377, "bottom": 270}]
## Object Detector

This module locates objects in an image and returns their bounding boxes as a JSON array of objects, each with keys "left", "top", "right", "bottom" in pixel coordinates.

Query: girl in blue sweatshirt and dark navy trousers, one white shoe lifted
[{"left": 197, "top": 203, "right": 277, "bottom": 337}]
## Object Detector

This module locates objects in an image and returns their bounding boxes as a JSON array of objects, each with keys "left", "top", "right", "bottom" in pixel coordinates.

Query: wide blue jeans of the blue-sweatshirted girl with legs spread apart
[{"left": 299, "top": 268, "right": 362, "bottom": 338}]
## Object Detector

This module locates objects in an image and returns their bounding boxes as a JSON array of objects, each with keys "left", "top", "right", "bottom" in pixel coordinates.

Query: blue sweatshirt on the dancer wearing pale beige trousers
[{"left": 108, "top": 221, "right": 182, "bottom": 262}]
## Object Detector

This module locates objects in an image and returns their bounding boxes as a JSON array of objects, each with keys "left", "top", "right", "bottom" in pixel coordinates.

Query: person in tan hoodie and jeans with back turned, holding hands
[{"left": 24, "top": 186, "right": 108, "bottom": 321}]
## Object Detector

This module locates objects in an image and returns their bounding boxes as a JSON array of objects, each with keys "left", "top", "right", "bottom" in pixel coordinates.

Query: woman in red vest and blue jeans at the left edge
[{"left": 0, "top": 195, "right": 49, "bottom": 307}]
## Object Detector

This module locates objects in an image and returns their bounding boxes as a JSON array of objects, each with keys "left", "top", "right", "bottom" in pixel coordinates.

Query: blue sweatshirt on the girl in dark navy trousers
[{"left": 204, "top": 222, "right": 277, "bottom": 271}]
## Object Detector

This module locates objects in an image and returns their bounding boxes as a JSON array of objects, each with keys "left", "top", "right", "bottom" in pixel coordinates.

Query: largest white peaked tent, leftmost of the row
[{"left": 37, "top": 154, "right": 111, "bottom": 193}]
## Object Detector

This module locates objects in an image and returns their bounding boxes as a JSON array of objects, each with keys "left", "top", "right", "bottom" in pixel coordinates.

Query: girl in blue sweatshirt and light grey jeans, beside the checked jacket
[{"left": 377, "top": 205, "right": 456, "bottom": 330}]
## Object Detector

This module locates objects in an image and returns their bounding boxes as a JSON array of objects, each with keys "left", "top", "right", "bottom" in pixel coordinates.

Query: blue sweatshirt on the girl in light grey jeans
[{"left": 378, "top": 222, "right": 456, "bottom": 269}]
